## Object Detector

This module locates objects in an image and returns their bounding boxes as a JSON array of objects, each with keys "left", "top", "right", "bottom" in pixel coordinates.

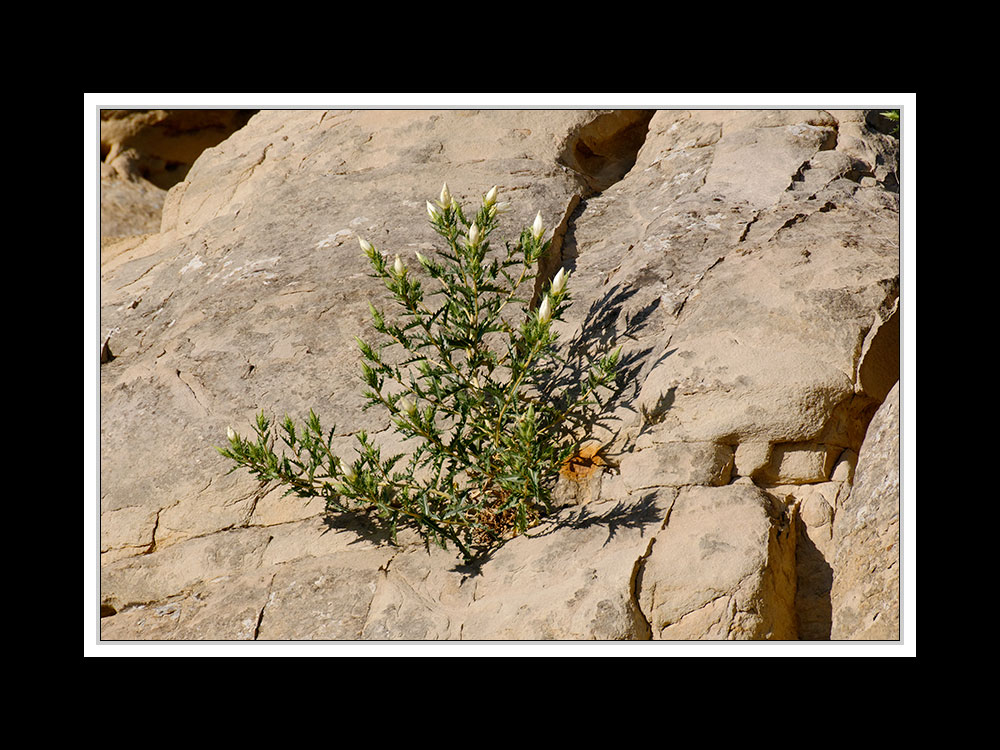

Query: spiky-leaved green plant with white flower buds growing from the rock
[{"left": 218, "top": 185, "right": 620, "bottom": 559}]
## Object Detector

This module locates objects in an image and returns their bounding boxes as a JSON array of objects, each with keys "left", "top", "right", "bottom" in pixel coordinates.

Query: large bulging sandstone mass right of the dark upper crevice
[{"left": 564, "top": 112, "right": 898, "bottom": 458}]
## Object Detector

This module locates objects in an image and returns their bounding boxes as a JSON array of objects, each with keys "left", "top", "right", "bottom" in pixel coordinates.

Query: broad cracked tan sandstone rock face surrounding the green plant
[{"left": 100, "top": 110, "right": 899, "bottom": 640}]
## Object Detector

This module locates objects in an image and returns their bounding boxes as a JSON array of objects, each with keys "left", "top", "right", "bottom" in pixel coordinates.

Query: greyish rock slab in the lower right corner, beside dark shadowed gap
[{"left": 830, "top": 384, "right": 900, "bottom": 640}]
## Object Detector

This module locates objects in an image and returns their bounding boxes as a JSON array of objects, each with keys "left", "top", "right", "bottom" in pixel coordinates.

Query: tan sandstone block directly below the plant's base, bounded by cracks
[{"left": 352, "top": 491, "right": 673, "bottom": 641}]
